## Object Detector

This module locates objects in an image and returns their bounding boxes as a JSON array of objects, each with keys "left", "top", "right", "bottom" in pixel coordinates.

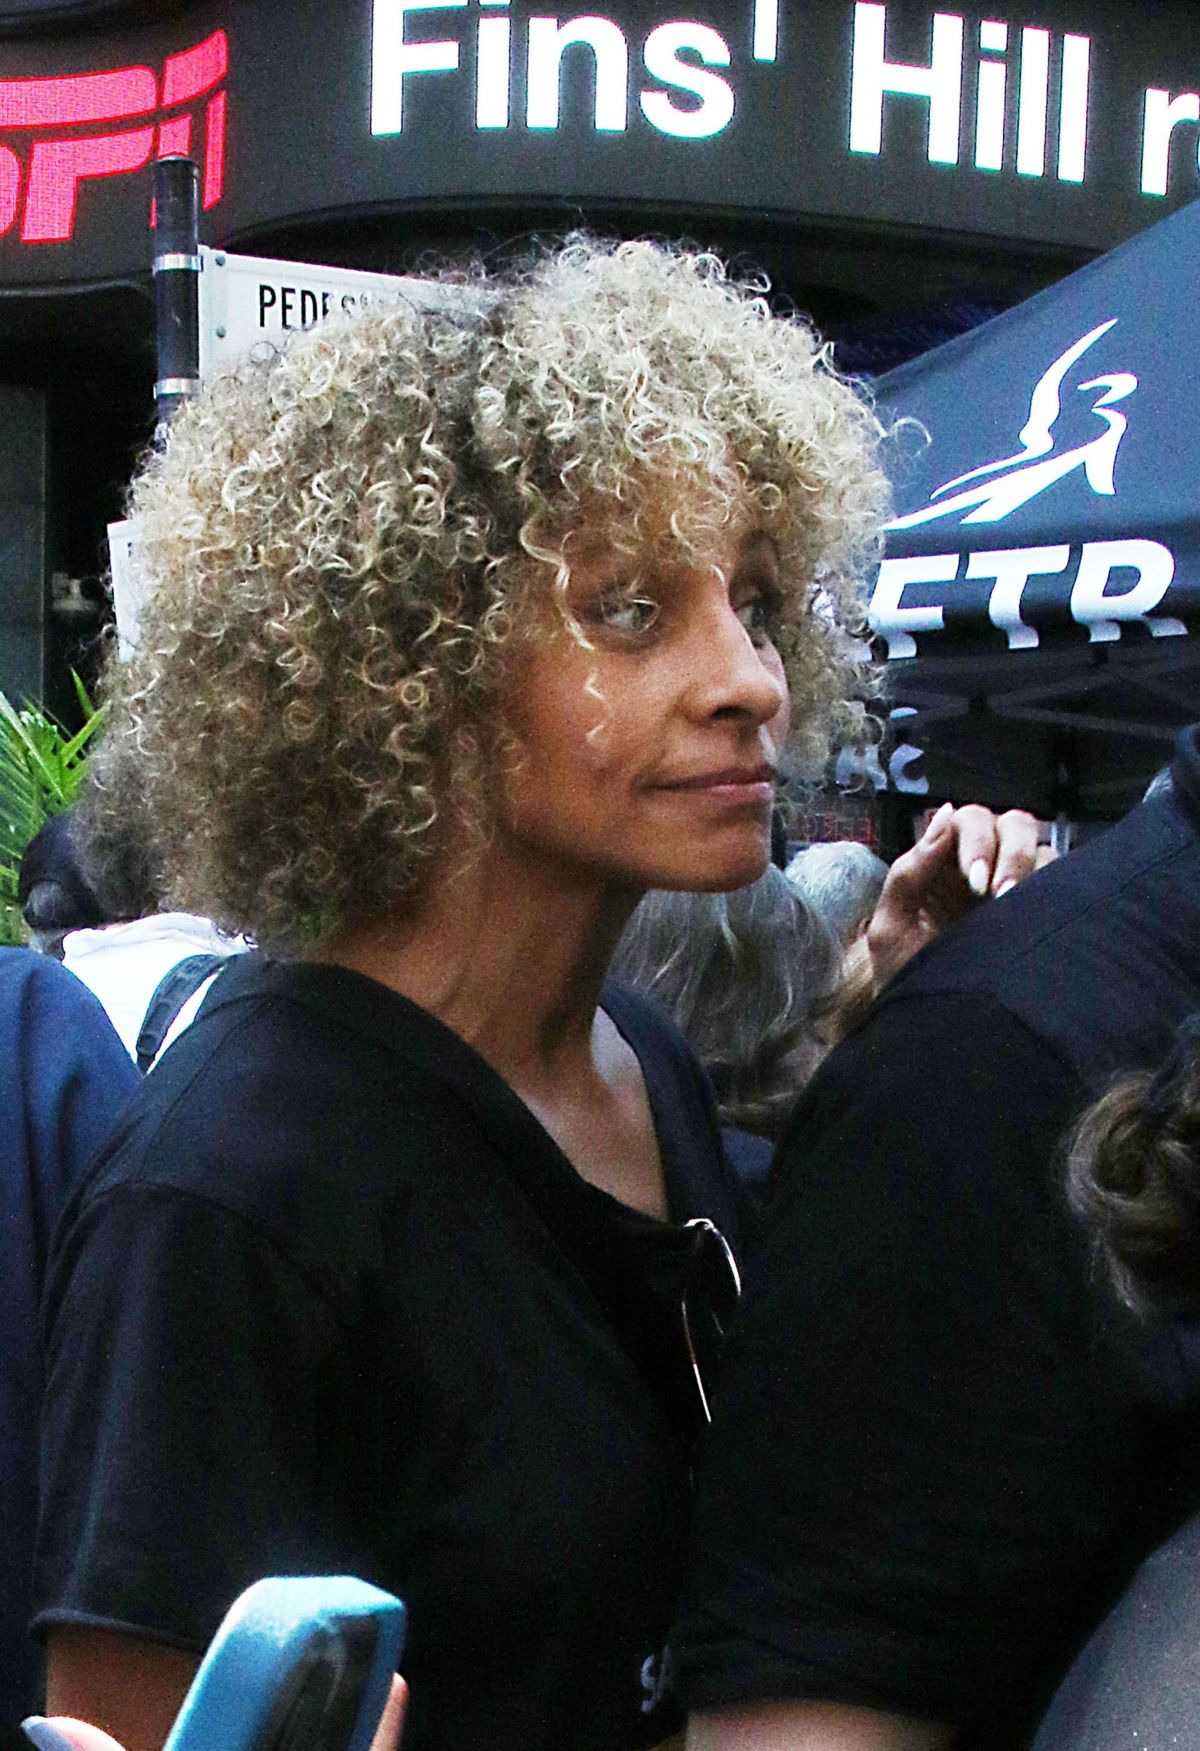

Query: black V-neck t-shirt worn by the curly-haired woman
[{"left": 37, "top": 956, "right": 736, "bottom": 1751}]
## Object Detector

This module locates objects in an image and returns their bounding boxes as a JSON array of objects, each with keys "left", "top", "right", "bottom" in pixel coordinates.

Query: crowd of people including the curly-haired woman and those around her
[{"left": 0, "top": 238, "right": 1200, "bottom": 1751}]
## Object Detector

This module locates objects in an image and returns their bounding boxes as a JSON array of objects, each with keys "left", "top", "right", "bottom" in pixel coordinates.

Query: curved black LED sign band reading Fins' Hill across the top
[{"left": 0, "top": 0, "right": 1200, "bottom": 282}]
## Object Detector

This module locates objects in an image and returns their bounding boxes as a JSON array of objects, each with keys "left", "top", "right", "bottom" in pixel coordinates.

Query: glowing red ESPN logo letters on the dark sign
[{"left": 0, "top": 30, "right": 229, "bottom": 243}]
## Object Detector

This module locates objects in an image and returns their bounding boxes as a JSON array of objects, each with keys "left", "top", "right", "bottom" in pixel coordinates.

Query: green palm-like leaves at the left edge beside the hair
[{"left": 0, "top": 676, "right": 105, "bottom": 944}]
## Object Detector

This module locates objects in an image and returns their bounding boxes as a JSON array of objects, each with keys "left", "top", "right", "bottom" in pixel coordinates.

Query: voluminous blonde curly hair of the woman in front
[{"left": 98, "top": 238, "right": 886, "bottom": 949}]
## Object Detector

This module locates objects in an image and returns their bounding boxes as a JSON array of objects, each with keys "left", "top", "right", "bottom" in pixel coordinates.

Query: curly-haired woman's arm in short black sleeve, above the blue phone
[{"left": 35, "top": 1185, "right": 347, "bottom": 1751}]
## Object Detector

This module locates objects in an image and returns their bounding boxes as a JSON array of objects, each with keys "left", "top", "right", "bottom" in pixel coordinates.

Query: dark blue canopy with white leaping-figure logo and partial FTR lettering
[{"left": 871, "top": 201, "right": 1200, "bottom": 660}]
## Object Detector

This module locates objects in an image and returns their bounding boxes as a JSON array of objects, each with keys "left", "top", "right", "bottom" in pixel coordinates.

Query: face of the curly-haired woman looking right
[{"left": 501, "top": 504, "right": 787, "bottom": 891}]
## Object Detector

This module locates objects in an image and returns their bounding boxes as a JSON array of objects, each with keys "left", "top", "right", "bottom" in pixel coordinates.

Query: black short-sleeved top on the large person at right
[{"left": 674, "top": 717, "right": 1200, "bottom": 1747}]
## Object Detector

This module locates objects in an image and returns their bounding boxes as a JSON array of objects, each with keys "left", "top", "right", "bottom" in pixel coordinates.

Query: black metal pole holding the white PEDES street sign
[{"left": 154, "top": 158, "right": 200, "bottom": 438}]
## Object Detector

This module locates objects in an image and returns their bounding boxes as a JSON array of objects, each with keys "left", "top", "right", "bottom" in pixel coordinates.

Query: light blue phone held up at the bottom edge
[{"left": 163, "top": 1576, "right": 405, "bottom": 1751}]
